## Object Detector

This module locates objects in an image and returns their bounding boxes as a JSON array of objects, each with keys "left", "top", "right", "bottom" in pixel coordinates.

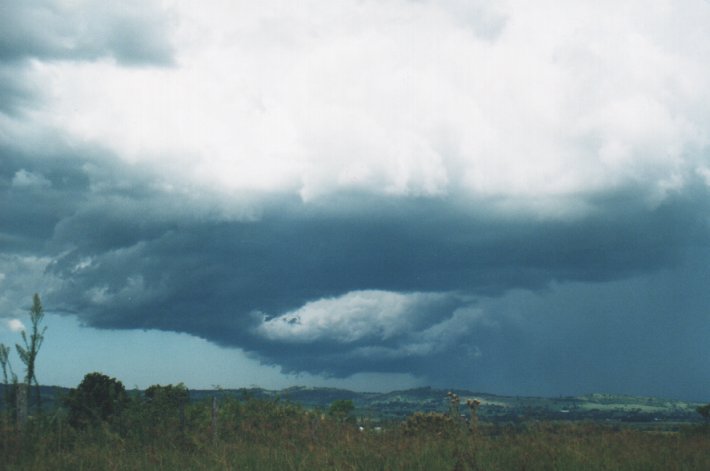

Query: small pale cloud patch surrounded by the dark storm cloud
[{"left": 256, "top": 291, "right": 489, "bottom": 360}]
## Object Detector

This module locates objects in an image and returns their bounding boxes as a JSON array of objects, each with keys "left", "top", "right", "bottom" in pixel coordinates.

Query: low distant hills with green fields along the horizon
[{"left": 0, "top": 385, "right": 701, "bottom": 424}]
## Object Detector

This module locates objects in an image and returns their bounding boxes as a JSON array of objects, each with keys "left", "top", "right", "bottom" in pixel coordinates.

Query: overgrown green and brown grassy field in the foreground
[{"left": 0, "top": 399, "right": 710, "bottom": 471}]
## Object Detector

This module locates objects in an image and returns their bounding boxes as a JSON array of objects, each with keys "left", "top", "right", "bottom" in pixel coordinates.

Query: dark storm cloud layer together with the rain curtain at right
[{"left": 0, "top": 138, "right": 710, "bottom": 396}]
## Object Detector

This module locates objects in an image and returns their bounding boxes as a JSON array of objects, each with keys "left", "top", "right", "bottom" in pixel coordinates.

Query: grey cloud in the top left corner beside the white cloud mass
[{"left": 0, "top": 0, "right": 173, "bottom": 65}]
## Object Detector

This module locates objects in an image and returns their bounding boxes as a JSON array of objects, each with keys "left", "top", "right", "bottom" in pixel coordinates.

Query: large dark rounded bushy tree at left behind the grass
[{"left": 64, "top": 373, "right": 128, "bottom": 428}]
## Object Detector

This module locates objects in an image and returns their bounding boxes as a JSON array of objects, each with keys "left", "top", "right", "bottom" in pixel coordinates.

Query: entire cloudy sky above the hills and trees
[{"left": 0, "top": 0, "right": 710, "bottom": 401}]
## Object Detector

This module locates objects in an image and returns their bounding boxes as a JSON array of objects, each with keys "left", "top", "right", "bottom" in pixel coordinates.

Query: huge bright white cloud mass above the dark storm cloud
[{"left": 18, "top": 0, "right": 710, "bottom": 211}]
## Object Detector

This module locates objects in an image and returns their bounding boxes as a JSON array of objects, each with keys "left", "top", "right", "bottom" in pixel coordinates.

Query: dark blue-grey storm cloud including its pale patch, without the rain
[{"left": 4, "top": 136, "right": 708, "bottom": 388}]
